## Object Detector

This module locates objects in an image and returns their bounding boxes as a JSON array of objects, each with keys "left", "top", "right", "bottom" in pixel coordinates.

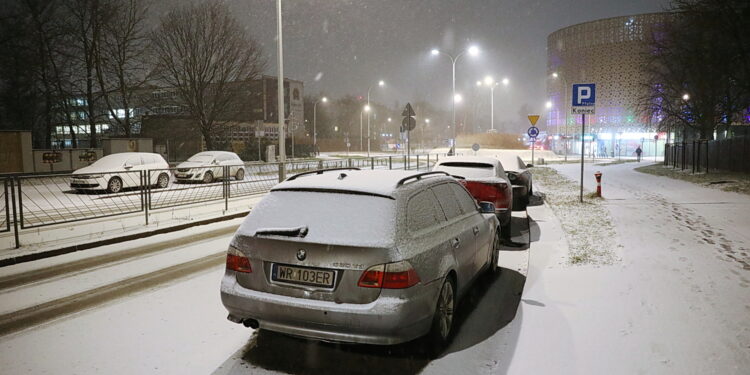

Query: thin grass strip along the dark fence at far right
[{"left": 635, "top": 164, "right": 750, "bottom": 194}]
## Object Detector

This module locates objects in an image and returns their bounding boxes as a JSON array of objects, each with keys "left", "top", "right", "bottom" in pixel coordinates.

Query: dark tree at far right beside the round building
[{"left": 639, "top": 0, "right": 750, "bottom": 139}]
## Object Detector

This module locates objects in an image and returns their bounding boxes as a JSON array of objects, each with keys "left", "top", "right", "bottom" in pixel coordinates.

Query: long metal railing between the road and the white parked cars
[{"left": 0, "top": 155, "right": 438, "bottom": 247}]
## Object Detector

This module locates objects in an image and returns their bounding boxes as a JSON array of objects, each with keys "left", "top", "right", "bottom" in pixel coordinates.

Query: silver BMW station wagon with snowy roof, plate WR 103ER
[{"left": 221, "top": 169, "right": 499, "bottom": 347}]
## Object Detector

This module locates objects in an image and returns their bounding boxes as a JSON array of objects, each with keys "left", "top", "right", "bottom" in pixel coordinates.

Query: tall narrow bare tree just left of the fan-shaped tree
[{"left": 94, "top": 0, "right": 151, "bottom": 137}]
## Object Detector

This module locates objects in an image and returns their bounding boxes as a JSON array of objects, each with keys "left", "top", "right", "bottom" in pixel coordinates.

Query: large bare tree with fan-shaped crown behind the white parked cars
[{"left": 151, "top": 1, "right": 265, "bottom": 149}]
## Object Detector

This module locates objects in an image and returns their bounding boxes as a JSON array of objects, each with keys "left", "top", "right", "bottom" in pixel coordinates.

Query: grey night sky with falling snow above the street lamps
[{"left": 164, "top": 0, "right": 668, "bottom": 128}]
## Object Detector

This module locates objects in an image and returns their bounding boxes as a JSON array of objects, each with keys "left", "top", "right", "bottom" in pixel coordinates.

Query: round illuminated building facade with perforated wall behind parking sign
[{"left": 546, "top": 13, "right": 671, "bottom": 156}]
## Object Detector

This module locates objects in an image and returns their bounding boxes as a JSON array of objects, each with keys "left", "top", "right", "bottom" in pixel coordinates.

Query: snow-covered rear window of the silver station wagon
[{"left": 238, "top": 190, "right": 396, "bottom": 247}]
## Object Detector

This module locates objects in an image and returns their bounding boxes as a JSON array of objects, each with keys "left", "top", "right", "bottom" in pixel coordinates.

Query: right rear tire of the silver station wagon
[{"left": 428, "top": 276, "right": 457, "bottom": 358}]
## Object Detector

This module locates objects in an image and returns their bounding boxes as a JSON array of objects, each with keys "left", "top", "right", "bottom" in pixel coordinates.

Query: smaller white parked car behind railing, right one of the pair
[{"left": 175, "top": 151, "right": 245, "bottom": 183}]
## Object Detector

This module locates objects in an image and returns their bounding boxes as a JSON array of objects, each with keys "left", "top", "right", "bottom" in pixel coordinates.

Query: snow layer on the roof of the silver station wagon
[{"left": 271, "top": 169, "right": 448, "bottom": 197}]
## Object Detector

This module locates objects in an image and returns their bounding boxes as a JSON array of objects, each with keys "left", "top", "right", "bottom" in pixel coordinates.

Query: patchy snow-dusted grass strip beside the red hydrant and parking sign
[{"left": 532, "top": 167, "right": 617, "bottom": 265}]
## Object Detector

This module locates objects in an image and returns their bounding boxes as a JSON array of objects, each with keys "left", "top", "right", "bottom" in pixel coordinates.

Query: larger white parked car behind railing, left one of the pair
[{"left": 70, "top": 152, "right": 170, "bottom": 193}]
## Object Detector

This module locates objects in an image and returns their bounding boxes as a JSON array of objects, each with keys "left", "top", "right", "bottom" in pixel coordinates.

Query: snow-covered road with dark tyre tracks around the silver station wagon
[{"left": 0, "top": 213, "right": 529, "bottom": 374}]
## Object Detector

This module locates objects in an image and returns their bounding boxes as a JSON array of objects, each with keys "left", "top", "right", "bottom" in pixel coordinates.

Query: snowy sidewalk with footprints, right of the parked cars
[{"left": 508, "top": 163, "right": 750, "bottom": 374}]
